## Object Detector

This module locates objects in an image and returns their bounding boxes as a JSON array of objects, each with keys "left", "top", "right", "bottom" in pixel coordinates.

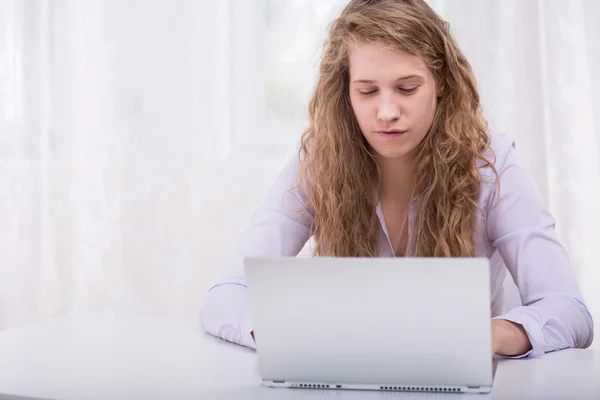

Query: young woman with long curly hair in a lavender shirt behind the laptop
[{"left": 201, "top": 0, "right": 593, "bottom": 357}]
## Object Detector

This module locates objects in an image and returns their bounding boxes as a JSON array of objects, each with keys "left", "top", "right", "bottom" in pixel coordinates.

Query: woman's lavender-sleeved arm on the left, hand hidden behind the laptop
[{"left": 200, "top": 158, "right": 313, "bottom": 348}]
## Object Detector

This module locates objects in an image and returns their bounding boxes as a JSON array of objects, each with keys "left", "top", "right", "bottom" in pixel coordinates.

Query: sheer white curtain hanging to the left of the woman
[{"left": 0, "top": 0, "right": 287, "bottom": 329}]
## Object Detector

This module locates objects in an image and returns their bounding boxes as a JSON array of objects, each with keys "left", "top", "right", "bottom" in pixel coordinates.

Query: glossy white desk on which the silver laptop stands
[{"left": 0, "top": 314, "right": 600, "bottom": 400}]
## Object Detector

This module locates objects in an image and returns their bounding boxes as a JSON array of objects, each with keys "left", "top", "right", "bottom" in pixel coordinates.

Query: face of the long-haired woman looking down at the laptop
[{"left": 350, "top": 44, "right": 437, "bottom": 162}]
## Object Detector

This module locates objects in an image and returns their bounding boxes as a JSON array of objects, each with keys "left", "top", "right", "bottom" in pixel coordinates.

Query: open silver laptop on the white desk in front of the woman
[{"left": 245, "top": 257, "right": 493, "bottom": 393}]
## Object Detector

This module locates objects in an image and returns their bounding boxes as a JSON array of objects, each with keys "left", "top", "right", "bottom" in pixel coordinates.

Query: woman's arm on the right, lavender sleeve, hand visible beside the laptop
[{"left": 487, "top": 139, "right": 593, "bottom": 356}]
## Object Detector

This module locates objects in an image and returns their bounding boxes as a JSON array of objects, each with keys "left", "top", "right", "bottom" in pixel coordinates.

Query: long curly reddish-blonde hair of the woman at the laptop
[{"left": 299, "top": 0, "right": 497, "bottom": 257}]
